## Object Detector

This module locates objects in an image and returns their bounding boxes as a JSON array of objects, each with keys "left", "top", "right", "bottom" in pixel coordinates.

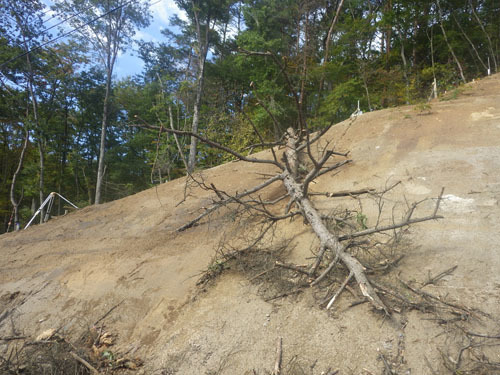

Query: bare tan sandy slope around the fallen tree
[{"left": 0, "top": 75, "right": 500, "bottom": 374}]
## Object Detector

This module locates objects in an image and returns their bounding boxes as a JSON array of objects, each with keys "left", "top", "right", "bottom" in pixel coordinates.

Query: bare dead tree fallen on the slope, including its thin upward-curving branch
[{"left": 133, "top": 50, "right": 442, "bottom": 314}]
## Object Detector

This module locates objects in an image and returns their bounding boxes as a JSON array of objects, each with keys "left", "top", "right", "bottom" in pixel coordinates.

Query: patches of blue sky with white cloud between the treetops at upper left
[{"left": 42, "top": 0, "right": 186, "bottom": 78}]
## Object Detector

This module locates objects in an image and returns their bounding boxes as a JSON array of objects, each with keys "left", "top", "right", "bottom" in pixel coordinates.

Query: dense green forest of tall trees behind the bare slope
[{"left": 0, "top": 0, "right": 500, "bottom": 233}]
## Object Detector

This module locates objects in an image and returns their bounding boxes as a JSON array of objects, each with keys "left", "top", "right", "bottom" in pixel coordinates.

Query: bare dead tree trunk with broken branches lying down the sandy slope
[{"left": 131, "top": 117, "right": 442, "bottom": 314}]
